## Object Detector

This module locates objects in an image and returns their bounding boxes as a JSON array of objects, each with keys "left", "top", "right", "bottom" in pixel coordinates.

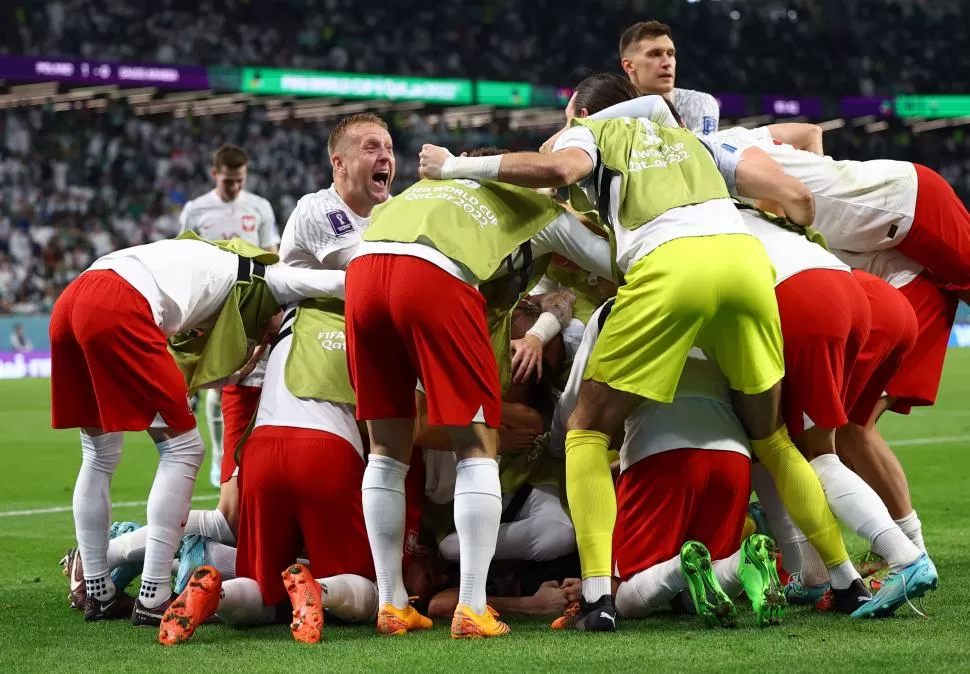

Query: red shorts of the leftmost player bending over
[{"left": 50, "top": 270, "right": 195, "bottom": 433}]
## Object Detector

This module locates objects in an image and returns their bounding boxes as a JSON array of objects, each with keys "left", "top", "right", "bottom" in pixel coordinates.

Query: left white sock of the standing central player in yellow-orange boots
[{"left": 361, "top": 454, "right": 408, "bottom": 609}]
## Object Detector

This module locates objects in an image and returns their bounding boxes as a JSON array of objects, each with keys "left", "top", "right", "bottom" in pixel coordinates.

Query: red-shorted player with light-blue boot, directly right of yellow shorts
[{"left": 741, "top": 207, "right": 936, "bottom": 617}]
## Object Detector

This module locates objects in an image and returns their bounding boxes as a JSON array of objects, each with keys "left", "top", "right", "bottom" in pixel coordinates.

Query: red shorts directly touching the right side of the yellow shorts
[{"left": 775, "top": 269, "right": 870, "bottom": 436}]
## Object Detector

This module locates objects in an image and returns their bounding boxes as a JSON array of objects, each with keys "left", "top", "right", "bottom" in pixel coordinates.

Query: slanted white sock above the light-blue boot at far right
[{"left": 810, "top": 454, "right": 920, "bottom": 571}]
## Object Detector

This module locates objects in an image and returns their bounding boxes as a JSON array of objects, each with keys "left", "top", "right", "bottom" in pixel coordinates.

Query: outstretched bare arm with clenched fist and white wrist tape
[{"left": 419, "top": 145, "right": 593, "bottom": 188}]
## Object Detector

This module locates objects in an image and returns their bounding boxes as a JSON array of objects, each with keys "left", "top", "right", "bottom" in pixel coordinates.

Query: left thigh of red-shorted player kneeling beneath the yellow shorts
[{"left": 613, "top": 449, "right": 702, "bottom": 578}]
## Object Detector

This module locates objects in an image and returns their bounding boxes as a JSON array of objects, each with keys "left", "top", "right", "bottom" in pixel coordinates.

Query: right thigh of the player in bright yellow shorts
[{"left": 698, "top": 234, "right": 785, "bottom": 395}]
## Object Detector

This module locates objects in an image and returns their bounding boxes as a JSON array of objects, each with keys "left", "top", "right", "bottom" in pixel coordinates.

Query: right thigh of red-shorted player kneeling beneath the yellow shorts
[{"left": 687, "top": 449, "right": 751, "bottom": 559}]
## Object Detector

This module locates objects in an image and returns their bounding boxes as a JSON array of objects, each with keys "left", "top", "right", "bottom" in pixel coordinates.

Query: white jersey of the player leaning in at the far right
[{"left": 715, "top": 127, "right": 917, "bottom": 252}]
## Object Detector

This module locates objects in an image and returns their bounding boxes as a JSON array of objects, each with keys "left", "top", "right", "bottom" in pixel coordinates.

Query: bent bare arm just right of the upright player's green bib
[{"left": 735, "top": 147, "right": 815, "bottom": 227}]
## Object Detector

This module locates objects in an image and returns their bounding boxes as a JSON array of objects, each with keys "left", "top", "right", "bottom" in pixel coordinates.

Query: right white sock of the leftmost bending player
[{"left": 138, "top": 428, "right": 205, "bottom": 608}]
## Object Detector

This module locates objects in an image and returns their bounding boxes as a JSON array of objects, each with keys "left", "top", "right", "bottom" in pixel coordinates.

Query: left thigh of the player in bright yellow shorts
[{"left": 584, "top": 237, "right": 716, "bottom": 402}]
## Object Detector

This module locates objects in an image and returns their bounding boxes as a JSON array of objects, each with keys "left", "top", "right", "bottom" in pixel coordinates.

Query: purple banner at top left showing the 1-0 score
[{"left": 0, "top": 55, "right": 209, "bottom": 89}]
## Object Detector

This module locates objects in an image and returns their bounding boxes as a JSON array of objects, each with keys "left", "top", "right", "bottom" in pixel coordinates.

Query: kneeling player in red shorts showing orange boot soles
[{"left": 159, "top": 296, "right": 377, "bottom": 645}]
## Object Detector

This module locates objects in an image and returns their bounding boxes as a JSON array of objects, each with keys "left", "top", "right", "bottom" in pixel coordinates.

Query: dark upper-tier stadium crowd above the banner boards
[{"left": 0, "top": 0, "right": 970, "bottom": 95}]
